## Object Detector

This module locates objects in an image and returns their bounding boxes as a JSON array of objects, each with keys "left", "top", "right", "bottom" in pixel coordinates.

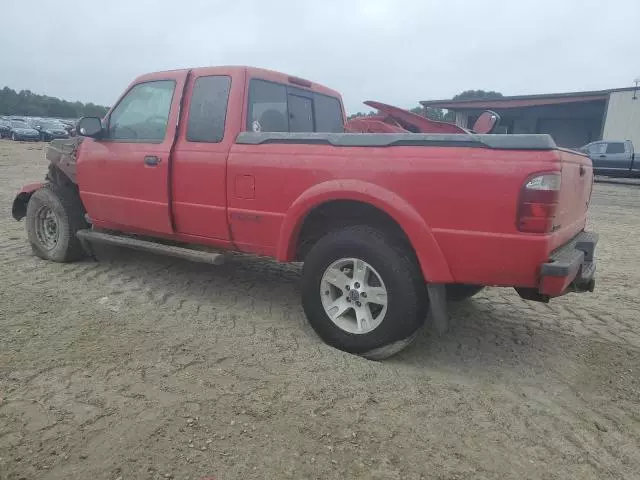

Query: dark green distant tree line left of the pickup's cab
[{"left": 0, "top": 87, "right": 109, "bottom": 118}]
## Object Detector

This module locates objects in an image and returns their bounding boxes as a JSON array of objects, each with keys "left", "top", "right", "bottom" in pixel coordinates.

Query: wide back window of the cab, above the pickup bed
[{"left": 247, "top": 80, "right": 344, "bottom": 133}]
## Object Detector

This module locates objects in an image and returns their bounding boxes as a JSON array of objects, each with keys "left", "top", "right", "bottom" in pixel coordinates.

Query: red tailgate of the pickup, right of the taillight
[{"left": 553, "top": 150, "right": 593, "bottom": 248}]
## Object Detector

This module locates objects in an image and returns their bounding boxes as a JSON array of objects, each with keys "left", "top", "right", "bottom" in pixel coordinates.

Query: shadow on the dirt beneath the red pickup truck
[{"left": 98, "top": 248, "right": 600, "bottom": 371}]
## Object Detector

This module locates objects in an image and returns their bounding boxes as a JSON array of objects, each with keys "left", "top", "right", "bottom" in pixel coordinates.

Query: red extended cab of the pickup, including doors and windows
[{"left": 72, "top": 67, "right": 344, "bottom": 248}]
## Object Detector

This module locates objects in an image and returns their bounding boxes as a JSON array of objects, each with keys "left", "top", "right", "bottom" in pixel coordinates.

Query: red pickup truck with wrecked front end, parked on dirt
[{"left": 13, "top": 67, "right": 597, "bottom": 358}]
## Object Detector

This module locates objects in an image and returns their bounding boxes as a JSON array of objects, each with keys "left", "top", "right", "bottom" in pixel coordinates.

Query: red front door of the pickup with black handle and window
[{"left": 77, "top": 71, "right": 187, "bottom": 234}]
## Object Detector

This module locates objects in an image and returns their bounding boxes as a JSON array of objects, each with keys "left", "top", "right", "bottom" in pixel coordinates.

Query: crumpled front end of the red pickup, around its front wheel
[{"left": 11, "top": 137, "right": 84, "bottom": 220}]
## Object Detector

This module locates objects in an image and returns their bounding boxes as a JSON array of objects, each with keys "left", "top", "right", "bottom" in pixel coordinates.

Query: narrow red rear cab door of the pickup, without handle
[{"left": 172, "top": 67, "right": 244, "bottom": 242}]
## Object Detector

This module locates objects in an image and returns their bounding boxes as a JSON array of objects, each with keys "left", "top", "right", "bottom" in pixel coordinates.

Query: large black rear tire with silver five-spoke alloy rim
[{"left": 301, "top": 226, "right": 428, "bottom": 360}]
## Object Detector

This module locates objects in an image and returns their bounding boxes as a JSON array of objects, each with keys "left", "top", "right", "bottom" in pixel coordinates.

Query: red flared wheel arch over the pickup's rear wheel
[{"left": 276, "top": 180, "right": 453, "bottom": 283}]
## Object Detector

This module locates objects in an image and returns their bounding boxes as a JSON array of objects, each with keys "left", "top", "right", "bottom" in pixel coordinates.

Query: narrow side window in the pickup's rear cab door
[{"left": 187, "top": 75, "right": 231, "bottom": 143}]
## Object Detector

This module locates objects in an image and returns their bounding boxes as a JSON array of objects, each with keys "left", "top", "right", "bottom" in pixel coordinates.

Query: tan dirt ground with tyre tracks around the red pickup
[{"left": 0, "top": 140, "right": 640, "bottom": 480}]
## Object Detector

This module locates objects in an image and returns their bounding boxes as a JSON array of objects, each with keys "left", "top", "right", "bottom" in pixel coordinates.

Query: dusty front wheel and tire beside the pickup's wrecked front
[{"left": 26, "top": 184, "right": 88, "bottom": 262}]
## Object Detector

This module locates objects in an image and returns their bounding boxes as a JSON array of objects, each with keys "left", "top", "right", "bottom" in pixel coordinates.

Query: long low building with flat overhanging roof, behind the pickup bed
[{"left": 420, "top": 87, "right": 640, "bottom": 148}]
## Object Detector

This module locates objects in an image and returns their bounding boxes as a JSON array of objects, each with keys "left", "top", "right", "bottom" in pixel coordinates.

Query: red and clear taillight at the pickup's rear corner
[{"left": 517, "top": 172, "right": 561, "bottom": 233}]
